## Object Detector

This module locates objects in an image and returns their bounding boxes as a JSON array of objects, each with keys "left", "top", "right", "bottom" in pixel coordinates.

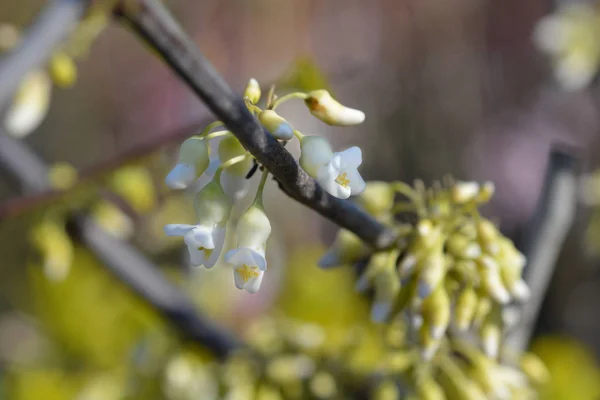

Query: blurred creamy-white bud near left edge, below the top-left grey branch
[{"left": 4, "top": 70, "right": 52, "bottom": 138}]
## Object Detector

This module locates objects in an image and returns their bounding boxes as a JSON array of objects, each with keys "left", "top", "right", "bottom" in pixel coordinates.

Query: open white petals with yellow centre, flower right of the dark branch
[{"left": 317, "top": 147, "right": 365, "bottom": 199}]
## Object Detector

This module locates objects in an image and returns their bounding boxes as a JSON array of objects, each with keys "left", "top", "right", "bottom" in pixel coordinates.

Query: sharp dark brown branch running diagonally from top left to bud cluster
[{"left": 116, "top": 0, "right": 396, "bottom": 248}]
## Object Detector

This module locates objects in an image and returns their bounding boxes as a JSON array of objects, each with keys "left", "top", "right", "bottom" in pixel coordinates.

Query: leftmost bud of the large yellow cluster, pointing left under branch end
[{"left": 319, "top": 229, "right": 372, "bottom": 268}]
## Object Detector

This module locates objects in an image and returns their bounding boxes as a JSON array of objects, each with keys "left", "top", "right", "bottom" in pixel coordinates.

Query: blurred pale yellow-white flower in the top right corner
[{"left": 533, "top": 3, "right": 600, "bottom": 90}]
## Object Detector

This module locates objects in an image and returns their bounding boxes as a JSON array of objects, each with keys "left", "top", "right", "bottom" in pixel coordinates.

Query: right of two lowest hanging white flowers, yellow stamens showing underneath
[{"left": 225, "top": 203, "right": 271, "bottom": 293}]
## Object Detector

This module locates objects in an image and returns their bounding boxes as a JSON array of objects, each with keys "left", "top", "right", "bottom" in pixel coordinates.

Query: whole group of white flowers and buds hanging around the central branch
[{"left": 165, "top": 79, "right": 365, "bottom": 293}]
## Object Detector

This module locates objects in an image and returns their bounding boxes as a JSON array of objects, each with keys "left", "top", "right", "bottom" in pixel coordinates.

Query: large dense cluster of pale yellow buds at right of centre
[{"left": 320, "top": 182, "right": 529, "bottom": 360}]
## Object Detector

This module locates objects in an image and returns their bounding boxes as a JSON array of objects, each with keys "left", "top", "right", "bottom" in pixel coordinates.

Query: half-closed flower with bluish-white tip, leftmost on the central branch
[{"left": 165, "top": 137, "right": 210, "bottom": 189}]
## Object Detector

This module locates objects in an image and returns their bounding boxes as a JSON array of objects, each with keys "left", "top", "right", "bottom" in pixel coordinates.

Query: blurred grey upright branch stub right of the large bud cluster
[{"left": 508, "top": 150, "right": 577, "bottom": 350}]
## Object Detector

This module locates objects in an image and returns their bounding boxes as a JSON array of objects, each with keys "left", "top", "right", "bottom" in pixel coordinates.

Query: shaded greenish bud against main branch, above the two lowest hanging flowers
[{"left": 219, "top": 136, "right": 252, "bottom": 202}]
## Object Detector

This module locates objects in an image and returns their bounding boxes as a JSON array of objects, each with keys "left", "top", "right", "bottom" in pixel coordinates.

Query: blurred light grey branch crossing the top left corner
[{"left": 0, "top": 0, "right": 91, "bottom": 111}]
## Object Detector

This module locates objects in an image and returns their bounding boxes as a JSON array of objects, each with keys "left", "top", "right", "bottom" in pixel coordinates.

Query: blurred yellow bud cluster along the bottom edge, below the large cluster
[{"left": 163, "top": 317, "right": 361, "bottom": 400}]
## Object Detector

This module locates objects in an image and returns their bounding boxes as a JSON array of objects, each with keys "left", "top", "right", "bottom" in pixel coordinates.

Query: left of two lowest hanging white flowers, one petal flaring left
[{"left": 165, "top": 180, "right": 232, "bottom": 268}]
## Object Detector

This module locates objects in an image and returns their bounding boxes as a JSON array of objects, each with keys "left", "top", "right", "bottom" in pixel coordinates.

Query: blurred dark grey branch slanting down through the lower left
[{"left": 0, "top": 130, "right": 241, "bottom": 357}]
